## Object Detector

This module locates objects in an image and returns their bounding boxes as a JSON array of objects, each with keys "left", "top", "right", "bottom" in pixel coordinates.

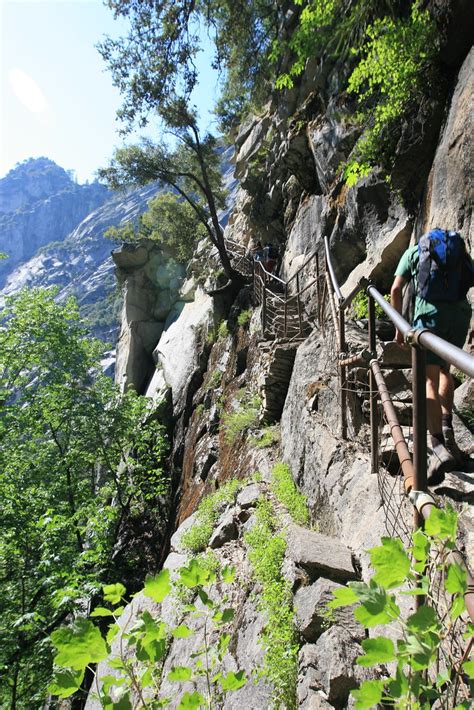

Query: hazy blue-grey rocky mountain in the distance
[{"left": 0, "top": 158, "right": 157, "bottom": 341}]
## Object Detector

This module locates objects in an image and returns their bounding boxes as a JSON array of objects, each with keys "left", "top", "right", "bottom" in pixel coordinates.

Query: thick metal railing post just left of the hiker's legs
[{"left": 411, "top": 345, "right": 427, "bottom": 527}]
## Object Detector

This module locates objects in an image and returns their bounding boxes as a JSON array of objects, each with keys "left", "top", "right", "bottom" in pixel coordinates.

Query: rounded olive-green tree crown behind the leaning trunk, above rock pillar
[{"left": 105, "top": 192, "right": 207, "bottom": 263}]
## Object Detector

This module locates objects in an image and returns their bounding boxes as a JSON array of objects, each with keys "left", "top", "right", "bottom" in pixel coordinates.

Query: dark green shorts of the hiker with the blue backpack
[{"left": 413, "top": 301, "right": 472, "bottom": 368}]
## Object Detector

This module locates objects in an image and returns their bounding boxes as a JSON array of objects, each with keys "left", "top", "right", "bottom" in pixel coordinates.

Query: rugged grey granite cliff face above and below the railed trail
[{"left": 88, "top": 13, "right": 474, "bottom": 710}]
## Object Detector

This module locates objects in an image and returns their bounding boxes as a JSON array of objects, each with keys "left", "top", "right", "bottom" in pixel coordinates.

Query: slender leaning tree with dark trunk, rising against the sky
[{"left": 99, "top": 0, "right": 278, "bottom": 284}]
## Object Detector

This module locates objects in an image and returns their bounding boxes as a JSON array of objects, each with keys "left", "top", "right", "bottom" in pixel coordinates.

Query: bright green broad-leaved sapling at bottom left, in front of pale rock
[{"left": 49, "top": 558, "right": 247, "bottom": 710}]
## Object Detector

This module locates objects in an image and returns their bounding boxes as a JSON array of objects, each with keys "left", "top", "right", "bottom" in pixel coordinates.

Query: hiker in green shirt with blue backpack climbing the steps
[{"left": 391, "top": 228, "right": 474, "bottom": 486}]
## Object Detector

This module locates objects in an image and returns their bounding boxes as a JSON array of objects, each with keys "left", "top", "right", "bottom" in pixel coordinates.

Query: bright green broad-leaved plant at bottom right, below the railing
[{"left": 329, "top": 508, "right": 474, "bottom": 710}]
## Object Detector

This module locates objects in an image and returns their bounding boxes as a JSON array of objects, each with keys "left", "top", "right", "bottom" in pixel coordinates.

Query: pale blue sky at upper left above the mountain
[{"left": 0, "top": 0, "right": 216, "bottom": 183}]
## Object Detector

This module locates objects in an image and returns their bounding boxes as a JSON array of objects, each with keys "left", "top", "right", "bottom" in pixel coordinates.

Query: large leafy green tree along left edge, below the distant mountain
[{"left": 0, "top": 289, "right": 167, "bottom": 708}]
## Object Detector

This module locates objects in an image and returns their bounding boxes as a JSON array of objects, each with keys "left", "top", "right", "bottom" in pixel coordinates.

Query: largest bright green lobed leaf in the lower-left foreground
[{"left": 51, "top": 619, "right": 108, "bottom": 670}]
